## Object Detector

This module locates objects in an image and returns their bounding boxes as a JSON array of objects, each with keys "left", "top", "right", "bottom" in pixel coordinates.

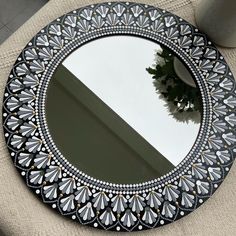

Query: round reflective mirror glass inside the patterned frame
[{"left": 46, "top": 35, "right": 202, "bottom": 184}]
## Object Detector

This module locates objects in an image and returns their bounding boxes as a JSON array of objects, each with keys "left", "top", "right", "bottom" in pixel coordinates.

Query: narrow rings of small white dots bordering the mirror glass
[{"left": 35, "top": 26, "right": 212, "bottom": 193}]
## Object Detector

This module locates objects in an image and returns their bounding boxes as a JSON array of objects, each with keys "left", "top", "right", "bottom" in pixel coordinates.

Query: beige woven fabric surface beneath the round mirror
[{"left": 0, "top": 0, "right": 236, "bottom": 236}]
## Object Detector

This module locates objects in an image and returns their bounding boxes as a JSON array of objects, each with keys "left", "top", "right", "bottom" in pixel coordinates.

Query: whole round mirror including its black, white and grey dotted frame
[{"left": 2, "top": 2, "right": 236, "bottom": 232}]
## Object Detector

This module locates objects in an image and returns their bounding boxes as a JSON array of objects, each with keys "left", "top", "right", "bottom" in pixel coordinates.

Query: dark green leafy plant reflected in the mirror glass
[{"left": 146, "top": 48, "right": 201, "bottom": 122}]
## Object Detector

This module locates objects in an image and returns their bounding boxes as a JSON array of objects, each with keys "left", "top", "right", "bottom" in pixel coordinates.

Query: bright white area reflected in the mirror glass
[{"left": 63, "top": 36, "right": 199, "bottom": 165}]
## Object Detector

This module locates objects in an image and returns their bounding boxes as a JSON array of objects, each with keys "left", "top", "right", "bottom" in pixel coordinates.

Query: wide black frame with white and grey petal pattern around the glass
[{"left": 3, "top": 2, "right": 236, "bottom": 231}]
